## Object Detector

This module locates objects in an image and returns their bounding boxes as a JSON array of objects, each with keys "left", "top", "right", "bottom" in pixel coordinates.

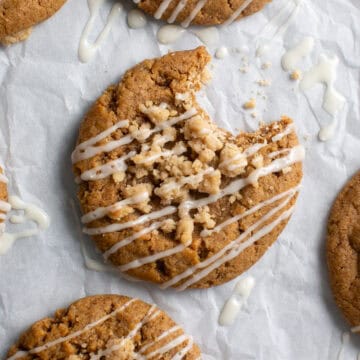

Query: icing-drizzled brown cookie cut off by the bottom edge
[{"left": 7, "top": 295, "right": 200, "bottom": 360}]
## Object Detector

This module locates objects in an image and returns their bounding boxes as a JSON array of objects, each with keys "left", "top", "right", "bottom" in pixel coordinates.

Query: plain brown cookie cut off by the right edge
[{"left": 327, "top": 172, "right": 360, "bottom": 326}]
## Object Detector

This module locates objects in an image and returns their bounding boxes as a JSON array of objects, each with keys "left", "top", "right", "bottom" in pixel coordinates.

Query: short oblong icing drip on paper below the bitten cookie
[{"left": 219, "top": 276, "right": 255, "bottom": 326}]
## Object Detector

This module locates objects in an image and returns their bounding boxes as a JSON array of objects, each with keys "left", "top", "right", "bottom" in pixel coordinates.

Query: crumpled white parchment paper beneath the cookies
[{"left": 0, "top": 0, "right": 360, "bottom": 360}]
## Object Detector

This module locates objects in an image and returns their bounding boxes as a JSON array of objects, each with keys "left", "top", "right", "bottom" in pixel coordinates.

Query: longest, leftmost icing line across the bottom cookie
[{"left": 8, "top": 299, "right": 138, "bottom": 360}]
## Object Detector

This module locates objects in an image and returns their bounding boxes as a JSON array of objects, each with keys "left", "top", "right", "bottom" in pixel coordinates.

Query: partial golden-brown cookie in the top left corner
[{"left": 0, "top": 0, "right": 66, "bottom": 45}]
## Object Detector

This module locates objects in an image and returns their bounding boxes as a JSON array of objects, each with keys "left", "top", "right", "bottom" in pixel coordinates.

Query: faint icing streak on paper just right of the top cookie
[{"left": 255, "top": 0, "right": 303, "bottom": 57}]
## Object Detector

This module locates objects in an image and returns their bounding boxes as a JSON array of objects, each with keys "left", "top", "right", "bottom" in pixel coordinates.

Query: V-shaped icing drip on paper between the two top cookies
[{"left": 79, "top": 0, "right": 122, "bottom": 62}]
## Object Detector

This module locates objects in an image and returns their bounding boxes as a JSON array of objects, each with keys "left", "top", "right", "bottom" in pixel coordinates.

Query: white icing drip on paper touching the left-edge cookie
[{"left": 0, "top": 196, "right": 50, "bottom": 255}]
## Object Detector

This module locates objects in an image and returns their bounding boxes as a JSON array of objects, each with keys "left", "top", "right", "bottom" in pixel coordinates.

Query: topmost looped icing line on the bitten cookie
[{"left": 71, "top": 108, "right": 197, "bottom": 163}]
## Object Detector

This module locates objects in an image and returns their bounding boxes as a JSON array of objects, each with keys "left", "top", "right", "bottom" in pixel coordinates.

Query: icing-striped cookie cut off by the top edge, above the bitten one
[{"left": 134, "top": 0, "right": 271, "bottom": 27}]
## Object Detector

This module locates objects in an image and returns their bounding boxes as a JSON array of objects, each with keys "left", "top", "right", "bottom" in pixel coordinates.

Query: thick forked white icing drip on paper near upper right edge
[{"left": 300, "top": 54, "right": 345, "bottom": 116}]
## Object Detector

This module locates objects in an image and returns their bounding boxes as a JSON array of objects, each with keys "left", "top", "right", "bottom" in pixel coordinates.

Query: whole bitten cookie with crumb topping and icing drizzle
[{"left": 72, "top": 47, "right": 304, "bottom": 290}]
